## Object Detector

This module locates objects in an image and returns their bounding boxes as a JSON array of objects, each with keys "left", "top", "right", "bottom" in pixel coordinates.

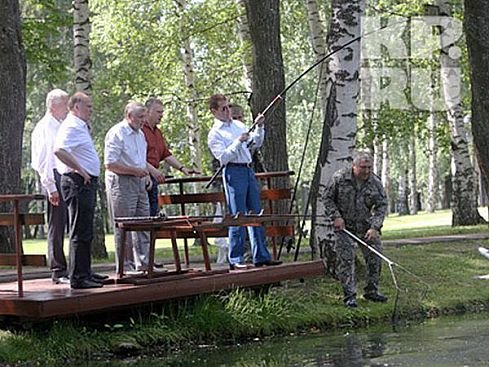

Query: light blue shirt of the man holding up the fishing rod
[{"left": 207, "top": 119, "right": 265, "bottom": 166}]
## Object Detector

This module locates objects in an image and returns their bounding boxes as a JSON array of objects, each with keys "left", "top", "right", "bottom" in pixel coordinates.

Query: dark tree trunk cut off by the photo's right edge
[{"left": 464, "top": 0, "right": 489, "bottom": 221}]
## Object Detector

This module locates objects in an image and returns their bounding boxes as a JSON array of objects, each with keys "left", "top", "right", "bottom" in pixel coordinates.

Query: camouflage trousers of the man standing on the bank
[{"left": 335, "top": 232, "right": 382, "bottom": 300}]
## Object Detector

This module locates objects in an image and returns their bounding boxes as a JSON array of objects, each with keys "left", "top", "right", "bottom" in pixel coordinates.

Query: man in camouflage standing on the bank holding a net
[{"left": 323, "top": 152, "right": 387, "bottom": 307}]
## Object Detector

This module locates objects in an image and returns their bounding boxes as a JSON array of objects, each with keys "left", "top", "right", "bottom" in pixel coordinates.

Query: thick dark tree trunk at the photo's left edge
[{"left": 0, "top": 0, "right": 26, "bottom": 252}]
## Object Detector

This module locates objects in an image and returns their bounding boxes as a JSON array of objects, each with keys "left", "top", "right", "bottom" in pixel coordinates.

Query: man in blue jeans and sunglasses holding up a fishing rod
[{"left": 207, "top": 94, "right": 282, "bottom": 270}]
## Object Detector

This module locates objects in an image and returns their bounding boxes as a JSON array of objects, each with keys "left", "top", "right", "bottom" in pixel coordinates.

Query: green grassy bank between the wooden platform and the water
[{"left": 0, "top": 237, "right": 489, "bottom": 366}]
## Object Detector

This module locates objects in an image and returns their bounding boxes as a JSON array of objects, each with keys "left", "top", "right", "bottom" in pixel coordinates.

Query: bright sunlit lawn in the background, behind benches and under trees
[{"left": 24, "top": 208, "right": 489, "bottom": 261}]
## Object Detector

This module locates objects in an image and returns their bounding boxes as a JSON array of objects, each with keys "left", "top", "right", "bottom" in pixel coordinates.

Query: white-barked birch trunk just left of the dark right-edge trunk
[{"left": 438, "top": 0, "right": 484, "bottom": 226}]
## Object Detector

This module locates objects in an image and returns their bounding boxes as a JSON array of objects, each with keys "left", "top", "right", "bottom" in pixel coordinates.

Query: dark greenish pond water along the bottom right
[{"left": 86, "top": 314, "right": 489, "bottom": 367}]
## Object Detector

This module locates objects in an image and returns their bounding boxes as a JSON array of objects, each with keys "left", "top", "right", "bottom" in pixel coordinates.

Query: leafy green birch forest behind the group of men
[{"left": 2, "top": 0, "right": 487, "bottom": 257}]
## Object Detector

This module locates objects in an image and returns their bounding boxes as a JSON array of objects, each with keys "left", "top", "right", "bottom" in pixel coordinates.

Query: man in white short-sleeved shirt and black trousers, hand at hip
[{"left": 54, "top": 92, "right": 103, "bottom": 289}]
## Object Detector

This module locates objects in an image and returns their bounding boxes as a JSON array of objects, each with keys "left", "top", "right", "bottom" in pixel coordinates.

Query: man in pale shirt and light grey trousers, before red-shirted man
[{"left": 104, "top": 102, "right": 165, "bottom": 272}]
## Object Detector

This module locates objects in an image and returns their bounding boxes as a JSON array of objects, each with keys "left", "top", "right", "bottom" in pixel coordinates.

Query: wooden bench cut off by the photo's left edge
[{"left": 0, "top": 194, "right": 47, "bottom": 297}]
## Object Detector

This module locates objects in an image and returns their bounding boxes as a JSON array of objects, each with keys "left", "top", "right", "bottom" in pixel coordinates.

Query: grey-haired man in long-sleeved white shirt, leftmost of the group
[{"left": 31, "top": 89, "right": 70, "bottom": 284}]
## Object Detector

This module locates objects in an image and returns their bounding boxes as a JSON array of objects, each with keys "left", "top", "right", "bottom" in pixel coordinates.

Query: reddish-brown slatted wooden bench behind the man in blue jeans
[{"left": 158, "top": 171, "right": 294, "bottom": 266}]
